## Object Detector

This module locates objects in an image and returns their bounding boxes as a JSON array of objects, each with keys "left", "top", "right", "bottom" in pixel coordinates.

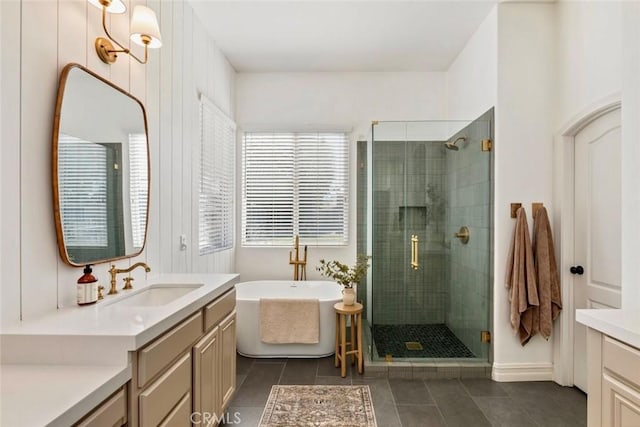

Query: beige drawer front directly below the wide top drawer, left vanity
[{"left": 139, "top": 353, "right": 191, "bottom": 427}]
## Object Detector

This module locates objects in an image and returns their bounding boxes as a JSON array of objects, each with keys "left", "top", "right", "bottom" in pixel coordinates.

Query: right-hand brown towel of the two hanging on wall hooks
[{"left": 533, "top": 207, "right": 562, "bottom": 339}]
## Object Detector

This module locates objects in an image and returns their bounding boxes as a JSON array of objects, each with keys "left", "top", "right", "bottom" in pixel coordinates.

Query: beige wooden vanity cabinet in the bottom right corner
[{"left": 587, "top": 328, "right": 640, "bottom": 427}]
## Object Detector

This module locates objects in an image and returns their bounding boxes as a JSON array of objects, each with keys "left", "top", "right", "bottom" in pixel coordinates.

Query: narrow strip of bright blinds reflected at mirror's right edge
[{"left": 129, "top": 133, "right": 149, "bottom": 249}]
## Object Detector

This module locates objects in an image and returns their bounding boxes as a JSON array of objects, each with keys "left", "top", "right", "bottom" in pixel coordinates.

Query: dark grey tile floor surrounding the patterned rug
[{"left": 223, "top": 356, "right": 587, "bottom": 427}]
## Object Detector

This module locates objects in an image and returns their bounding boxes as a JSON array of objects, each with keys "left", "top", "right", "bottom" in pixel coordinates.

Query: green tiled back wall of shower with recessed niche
[{"left": 372, "top": 141, "right": 448, "bottom": 324}]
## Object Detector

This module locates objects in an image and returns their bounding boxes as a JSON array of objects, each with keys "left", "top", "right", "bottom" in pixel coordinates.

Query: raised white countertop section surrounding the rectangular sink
[{"left": 1, "top": 274, "right": 238, "bottom": 365}]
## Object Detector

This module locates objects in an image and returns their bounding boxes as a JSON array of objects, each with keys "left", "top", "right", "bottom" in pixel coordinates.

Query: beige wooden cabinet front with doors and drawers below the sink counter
[{"left": 128, "top": 289, "right": 236, "bottom": 427}]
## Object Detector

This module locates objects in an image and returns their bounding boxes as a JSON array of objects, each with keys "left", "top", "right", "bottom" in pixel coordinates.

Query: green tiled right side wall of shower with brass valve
[{"left": 446, "top": 110, "right": 493, "bottom": 358}]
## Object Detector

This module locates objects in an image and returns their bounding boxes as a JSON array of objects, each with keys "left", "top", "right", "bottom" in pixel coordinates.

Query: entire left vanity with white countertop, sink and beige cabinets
[{"left": 0, "top": 273, "right": 238, "bottom": 427}]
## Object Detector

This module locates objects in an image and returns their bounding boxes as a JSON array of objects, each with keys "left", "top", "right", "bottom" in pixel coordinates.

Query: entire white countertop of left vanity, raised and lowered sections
[{"left": 0, "top": 274, "right": 238, "bottom": 426}]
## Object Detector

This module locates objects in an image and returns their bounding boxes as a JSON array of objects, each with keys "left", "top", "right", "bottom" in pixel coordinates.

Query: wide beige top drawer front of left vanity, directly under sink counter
[{"left": 138, "top": 311, "right": 202, "bottom": 387}]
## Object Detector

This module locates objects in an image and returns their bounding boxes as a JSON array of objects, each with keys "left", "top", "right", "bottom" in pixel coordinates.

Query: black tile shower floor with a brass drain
[{"left": 373, "top": 324, "right": 475, "bottom": 359}]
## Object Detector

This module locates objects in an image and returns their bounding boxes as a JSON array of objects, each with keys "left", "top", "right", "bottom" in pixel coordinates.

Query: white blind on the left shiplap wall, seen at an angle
[{"left": 198, "top": 96, "right": 236, "bottom": 255}]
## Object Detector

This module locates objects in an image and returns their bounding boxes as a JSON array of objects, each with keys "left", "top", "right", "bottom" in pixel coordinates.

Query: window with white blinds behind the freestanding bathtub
[{"left": 242, "top": 132, "right": 349, "bottom": 246}]
